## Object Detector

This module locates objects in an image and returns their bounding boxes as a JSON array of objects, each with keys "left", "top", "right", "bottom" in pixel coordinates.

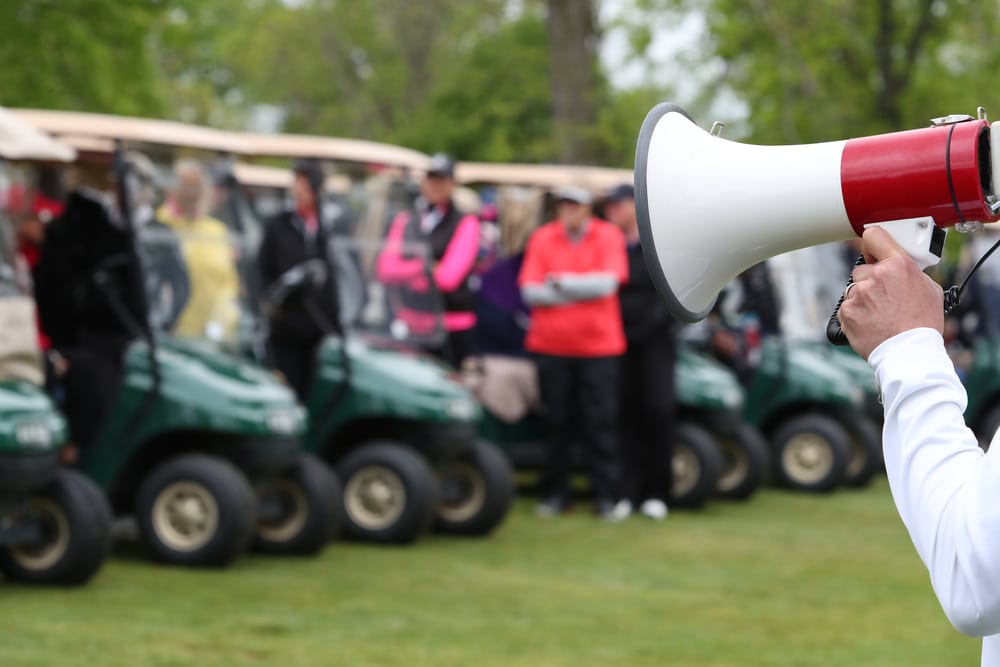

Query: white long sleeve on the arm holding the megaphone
[{"left": 868, "top": 329, "right": 1000, "bottom": 666}]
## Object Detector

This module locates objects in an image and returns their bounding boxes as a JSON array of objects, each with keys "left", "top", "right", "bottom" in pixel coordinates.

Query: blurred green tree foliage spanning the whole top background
[{"left": 17, "top": 0, "right": 1000, "bottom": 166}]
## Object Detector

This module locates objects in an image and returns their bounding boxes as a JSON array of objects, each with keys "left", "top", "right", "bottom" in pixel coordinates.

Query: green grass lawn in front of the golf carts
[{"left": 0, "top": 478, "right": 980, "bottom": 667}]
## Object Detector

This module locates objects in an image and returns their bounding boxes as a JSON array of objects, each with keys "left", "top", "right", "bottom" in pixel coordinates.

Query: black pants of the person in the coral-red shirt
[{"left": 534, "top": 354, "right": 623, "bottom": 502}]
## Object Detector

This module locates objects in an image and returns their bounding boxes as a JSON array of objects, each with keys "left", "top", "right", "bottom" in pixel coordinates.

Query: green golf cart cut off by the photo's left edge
[{"left": 0, "top": 120, "right": 112, "bottom": 585}]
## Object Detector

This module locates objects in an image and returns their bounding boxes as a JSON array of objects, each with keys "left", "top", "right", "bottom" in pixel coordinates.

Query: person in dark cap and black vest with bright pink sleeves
[{"left": 377, "top": 153, "right": 480, "bottom": 369}]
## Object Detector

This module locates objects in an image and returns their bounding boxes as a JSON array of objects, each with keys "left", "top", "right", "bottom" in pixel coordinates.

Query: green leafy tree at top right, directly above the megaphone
[{"left": 642, "top": 0, "right": 1000, "bottom": 143}]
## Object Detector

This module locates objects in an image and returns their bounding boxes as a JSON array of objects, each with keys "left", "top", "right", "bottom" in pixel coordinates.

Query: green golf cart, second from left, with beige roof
[{"left": 3, "top": 112, "right": 340, "bottom": 567}]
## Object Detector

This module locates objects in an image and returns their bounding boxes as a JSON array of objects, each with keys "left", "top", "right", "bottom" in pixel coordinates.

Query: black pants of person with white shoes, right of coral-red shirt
[{"left": 620, "top": 336, "right": 677, "bottom": 504}]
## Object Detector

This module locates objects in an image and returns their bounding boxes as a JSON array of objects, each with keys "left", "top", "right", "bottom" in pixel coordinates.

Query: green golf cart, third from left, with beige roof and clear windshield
[{"left": 230, "top": 134, "right": 514, "bottom": 544}]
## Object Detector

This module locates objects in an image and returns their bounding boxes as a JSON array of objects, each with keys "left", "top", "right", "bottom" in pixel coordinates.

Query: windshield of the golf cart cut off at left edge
[{"left": 0, "top": 160, "right": 44, "bottom": 385}]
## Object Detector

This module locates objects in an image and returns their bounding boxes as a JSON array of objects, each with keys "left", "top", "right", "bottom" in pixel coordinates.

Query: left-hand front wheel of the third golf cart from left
[{"left": 337, "top": 441, "right": 437, "bottom": 544}]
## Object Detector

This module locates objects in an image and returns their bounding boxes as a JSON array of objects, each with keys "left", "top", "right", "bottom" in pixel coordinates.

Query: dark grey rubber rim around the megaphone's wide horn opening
[{"left": 635, "top": 102, "right": 714, "bottom": 322}]
